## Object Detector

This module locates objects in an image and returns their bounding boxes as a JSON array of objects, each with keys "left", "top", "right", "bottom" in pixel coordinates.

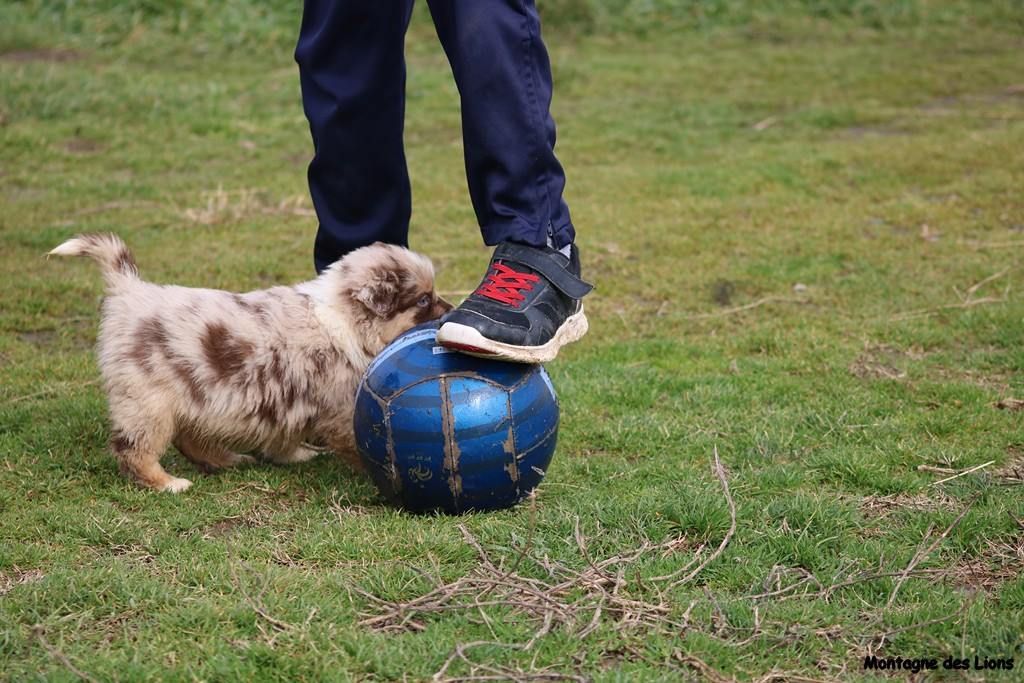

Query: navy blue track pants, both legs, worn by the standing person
[{"left": 295, "top": 0, "right": 574, "bottom": 271}]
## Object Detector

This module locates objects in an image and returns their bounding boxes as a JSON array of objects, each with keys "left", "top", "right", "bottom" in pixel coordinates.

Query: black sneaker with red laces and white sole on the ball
[{"left": 437, "top": 242, "right": 594, "bottom": 362}]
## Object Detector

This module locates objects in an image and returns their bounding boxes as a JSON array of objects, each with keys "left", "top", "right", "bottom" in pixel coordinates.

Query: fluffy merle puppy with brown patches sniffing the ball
[{"left": 50, "top": 234, "right": 452, "bottom": 493}]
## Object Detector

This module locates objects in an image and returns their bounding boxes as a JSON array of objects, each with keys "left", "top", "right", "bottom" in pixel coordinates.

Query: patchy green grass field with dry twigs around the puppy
[{"left": 0, "top": 0, "right": 1024, "bottom": 681}]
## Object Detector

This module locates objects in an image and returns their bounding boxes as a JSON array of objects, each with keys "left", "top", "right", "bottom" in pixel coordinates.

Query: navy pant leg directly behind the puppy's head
[{"left": 295, "top": 0, "right": 413, "bottom": 272}]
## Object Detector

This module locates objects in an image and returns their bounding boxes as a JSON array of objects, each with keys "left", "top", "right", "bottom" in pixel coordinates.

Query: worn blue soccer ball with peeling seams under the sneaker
[{"left": 354, "top": 322, "right": 558, "bottom": 513}]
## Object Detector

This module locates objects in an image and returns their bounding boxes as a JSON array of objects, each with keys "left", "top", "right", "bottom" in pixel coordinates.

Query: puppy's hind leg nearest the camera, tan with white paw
[{"left": 111, "top": 413, "right": 191, "bottom": 494}]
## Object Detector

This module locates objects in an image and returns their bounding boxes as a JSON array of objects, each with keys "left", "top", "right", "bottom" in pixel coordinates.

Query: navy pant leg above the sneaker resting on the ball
[{"left": 428, "top": 0, "right": 574, "bottom": 247}]
